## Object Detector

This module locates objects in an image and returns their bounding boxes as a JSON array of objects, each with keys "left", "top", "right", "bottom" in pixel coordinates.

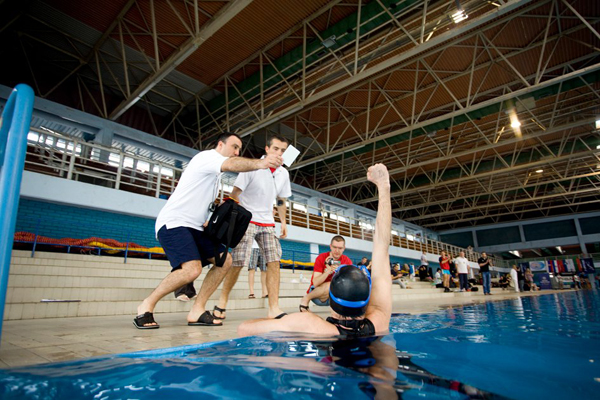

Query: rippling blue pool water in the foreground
[{"left": 0, "top": 291, "right": 600, "bottom": 400}]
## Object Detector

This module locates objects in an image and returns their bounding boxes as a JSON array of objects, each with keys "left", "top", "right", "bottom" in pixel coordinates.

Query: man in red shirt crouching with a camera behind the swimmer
[{"left": 300, "top": 235, "right": 352, "bottom": 312}]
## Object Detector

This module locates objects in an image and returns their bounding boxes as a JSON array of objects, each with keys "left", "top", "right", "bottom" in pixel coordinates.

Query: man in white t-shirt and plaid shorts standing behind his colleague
[{"left": 213, "top": 136, "right": 292, "bottom": 319}]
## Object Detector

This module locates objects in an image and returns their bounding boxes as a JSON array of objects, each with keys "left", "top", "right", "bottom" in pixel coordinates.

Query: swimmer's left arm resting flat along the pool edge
[{"left": 238, "top": 313, "right": 338, "bottom": 337}]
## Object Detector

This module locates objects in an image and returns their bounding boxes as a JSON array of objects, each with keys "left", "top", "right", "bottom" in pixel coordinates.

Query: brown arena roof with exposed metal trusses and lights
[{"left": 0, "top": 0, "right": 600, "bottom": 231}]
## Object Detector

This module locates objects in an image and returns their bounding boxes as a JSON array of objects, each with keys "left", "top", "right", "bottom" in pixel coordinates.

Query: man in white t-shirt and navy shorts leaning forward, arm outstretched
[{"left": 133, "top": 133, "right": 283, "bottom": 329}]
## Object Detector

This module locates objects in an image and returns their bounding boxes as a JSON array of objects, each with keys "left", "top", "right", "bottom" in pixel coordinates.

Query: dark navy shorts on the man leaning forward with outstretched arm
[{"left": 158, "top": 225, "right": 225, "bottom": 271}]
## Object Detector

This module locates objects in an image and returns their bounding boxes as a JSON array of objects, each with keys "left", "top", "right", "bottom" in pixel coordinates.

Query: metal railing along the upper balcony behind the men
[{"left": 18, "top": 121, "right": 508, "bottom": 267}]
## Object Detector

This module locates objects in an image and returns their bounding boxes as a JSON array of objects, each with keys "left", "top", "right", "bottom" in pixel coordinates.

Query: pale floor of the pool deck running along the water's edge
[{"left": 0, "top": 289, "right": 565, "bottom": 368}]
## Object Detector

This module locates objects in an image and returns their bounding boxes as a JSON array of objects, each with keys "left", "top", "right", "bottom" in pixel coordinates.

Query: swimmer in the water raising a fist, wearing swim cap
[{"left": 238, "top": 164, "right": 392, "bottom": 337}]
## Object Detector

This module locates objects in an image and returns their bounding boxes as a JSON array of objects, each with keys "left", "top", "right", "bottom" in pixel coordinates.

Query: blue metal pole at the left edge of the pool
[{"left": 0, "top": 84, "right": 34, "bottom": 339}]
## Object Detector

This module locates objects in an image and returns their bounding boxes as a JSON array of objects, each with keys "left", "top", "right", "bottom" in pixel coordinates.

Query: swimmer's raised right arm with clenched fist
[{"left": 366, "top": 164, "right": 392, "bottom": 332}]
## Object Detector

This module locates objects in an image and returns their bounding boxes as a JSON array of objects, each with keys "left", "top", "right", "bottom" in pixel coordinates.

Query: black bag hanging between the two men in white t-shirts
[{"left": 204, "top": 197, "right": 252, "bottom": 267}]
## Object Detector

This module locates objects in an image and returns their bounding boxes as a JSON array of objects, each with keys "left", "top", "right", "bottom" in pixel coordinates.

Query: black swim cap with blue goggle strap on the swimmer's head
[{"left": 329, "top": 265, "right": 371, "bottom": 317}]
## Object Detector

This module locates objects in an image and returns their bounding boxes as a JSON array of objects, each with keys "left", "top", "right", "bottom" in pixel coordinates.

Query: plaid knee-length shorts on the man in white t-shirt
[{"left": 231, "top": 224, "right": 281, "bottom": 268}]
